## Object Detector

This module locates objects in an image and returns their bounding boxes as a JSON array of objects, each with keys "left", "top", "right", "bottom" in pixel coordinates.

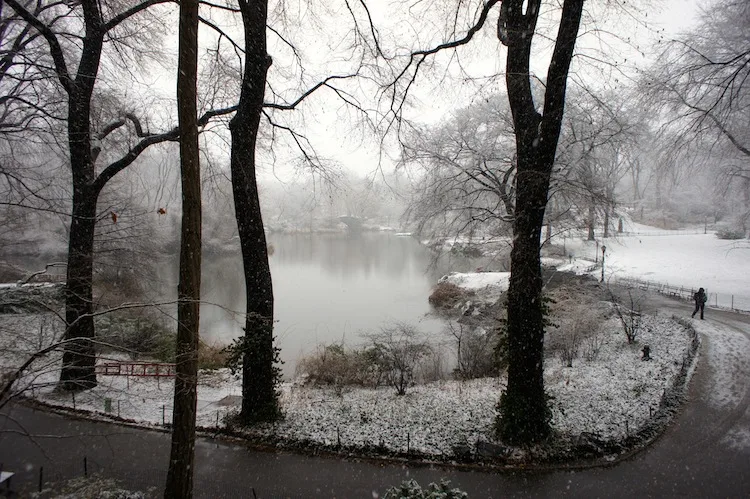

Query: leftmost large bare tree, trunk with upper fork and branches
[{"left": 6, "top": 0, "right": 242, "bottom": 390}]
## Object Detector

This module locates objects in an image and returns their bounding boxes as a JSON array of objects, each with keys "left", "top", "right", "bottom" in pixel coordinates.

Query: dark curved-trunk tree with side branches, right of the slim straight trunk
[{"left": 203, "top": 0, "right": 376, "bottom": 422}]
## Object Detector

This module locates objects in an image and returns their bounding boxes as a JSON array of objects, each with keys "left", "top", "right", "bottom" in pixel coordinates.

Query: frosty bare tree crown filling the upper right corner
[{"left": 641, "top": 0, "right": 750, "bottom": 230}]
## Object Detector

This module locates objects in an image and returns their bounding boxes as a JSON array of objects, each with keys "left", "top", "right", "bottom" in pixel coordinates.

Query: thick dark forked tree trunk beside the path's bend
[{"left": 498, "top": 0, "right": 583, "bottom": 445}]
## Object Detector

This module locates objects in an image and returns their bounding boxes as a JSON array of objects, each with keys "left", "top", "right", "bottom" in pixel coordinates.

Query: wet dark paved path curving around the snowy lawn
[{"left": 0, "top": 298, "right": 750, "bottom": 499}]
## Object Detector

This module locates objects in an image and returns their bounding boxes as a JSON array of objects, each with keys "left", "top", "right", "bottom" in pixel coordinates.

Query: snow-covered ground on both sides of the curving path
[{"left": 0, "top": 223, "right": 750, "bottom": 457}]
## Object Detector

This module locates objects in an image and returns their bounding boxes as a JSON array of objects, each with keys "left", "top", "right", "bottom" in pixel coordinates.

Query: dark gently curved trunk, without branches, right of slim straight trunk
[{"left": 229, "top": 0, "right": 279, "bottom": 423}]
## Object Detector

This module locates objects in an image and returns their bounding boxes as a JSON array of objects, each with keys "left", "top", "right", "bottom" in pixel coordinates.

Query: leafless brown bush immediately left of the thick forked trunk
[{"left": 445, "top": 322, "right": 498, "bottom": 380}]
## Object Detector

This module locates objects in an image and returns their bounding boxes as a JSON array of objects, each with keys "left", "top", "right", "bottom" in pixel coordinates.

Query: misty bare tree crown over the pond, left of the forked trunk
[{"left": 401, "top": 95, "right": 515, "bottom": 242}]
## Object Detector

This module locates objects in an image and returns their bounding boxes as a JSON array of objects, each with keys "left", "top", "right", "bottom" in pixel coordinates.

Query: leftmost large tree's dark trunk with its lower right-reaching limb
[{"left": 4, "top": 0, "right": 177, "bottom": 390}]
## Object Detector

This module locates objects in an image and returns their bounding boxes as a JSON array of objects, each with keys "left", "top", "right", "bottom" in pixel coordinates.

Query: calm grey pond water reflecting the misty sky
[{"left": 182, "top": 233, "right": 469, "bottom": 377}]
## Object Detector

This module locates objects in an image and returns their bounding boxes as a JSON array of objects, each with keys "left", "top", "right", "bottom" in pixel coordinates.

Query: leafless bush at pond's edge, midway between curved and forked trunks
[{"left": 369, "top": 323, "right": 431, "bottom": 395}]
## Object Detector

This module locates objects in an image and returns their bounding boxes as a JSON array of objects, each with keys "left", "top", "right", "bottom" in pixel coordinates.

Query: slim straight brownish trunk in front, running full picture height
[{"left": 164, "top": 0, "right": 201, "bottom": 499}]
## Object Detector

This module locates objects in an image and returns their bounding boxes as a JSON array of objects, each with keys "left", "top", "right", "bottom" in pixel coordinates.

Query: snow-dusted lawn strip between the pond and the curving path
[{"left": 0, "top": 315, "right": 704, "bottom": 459}]
